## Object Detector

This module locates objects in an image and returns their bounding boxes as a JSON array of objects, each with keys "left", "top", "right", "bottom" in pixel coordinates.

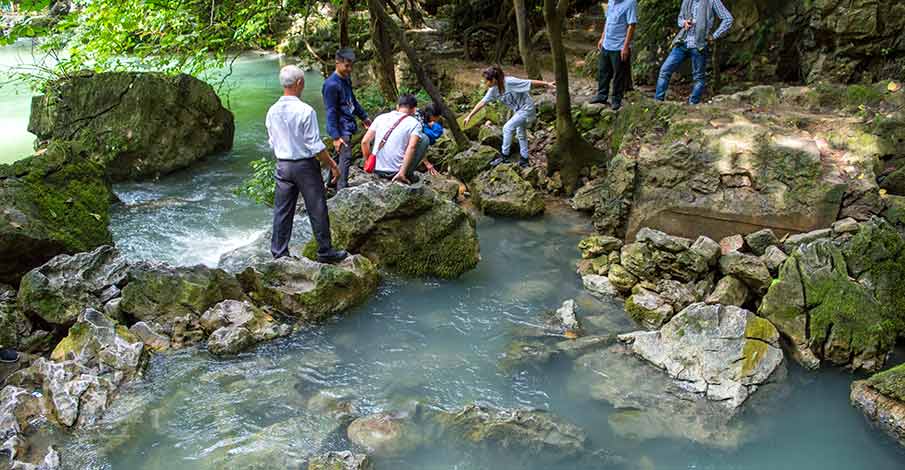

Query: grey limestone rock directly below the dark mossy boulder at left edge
[{"left": 19, "top": 246, "right": 128, "bottom": 326}]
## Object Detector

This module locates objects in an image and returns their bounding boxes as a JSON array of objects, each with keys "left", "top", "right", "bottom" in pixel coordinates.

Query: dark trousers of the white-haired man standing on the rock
[{"left": 270, "top": 158, "right": 333, "bottom": 258}]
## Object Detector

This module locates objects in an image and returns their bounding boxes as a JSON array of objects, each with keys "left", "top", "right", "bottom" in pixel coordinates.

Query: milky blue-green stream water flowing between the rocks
[{"left": 0, "top": 49, "right": 905, "bottom": 470}]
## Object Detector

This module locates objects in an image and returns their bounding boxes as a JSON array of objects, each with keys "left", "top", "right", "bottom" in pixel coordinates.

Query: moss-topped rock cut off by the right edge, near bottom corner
[{"left": 851, "top": 365, "right": 905, "bottom": 446}]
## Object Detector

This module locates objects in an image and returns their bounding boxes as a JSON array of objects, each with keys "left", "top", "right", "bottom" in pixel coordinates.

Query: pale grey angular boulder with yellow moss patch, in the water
[{"left": 619, "top": 304, "right": 783, "bottom": 410}]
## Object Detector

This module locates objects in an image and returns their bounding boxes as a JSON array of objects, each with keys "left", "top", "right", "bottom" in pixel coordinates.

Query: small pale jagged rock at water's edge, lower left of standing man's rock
[{"left": 200, "top": 300, "right": 292, "bottom": 356}]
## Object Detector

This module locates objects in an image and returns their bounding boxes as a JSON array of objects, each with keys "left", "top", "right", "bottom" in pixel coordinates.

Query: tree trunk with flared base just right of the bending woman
[{"left": 544, "top": 0, "right": 606, "bottom": 193}]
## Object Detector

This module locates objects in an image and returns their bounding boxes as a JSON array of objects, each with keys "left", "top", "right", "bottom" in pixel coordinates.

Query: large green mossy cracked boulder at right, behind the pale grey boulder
[{"left": 759, "top": 220, "right": 905, "bottom": 370}]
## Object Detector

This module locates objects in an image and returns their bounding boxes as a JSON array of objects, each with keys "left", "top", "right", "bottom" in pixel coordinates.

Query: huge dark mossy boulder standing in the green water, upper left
[{"left": 28, "top": 72, "right": 235, "bottom": 181}]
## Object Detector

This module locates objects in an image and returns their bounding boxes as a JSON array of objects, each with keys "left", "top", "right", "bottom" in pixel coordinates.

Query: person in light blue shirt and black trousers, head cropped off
[{"left": 591, "top": 0, "right": 638, "bottom": 110}]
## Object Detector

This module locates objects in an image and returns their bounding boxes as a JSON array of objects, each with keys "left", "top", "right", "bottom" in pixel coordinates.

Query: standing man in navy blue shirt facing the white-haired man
[{"left": 322, "top": 49, "right": 371, "bottom": 190}]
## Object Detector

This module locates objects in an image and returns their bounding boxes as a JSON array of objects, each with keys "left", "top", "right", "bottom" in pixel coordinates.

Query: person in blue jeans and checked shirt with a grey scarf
[{"left": 654, "top": 0, "right": 733, "bottom": 104}]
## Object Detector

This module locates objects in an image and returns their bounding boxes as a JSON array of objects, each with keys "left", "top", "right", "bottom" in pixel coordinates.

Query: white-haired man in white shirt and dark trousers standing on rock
[{"left": 266, "top": 65, "right": 349, "bottom": 263}]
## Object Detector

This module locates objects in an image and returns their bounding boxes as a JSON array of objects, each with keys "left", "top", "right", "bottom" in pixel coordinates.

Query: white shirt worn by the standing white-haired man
[{"left": 266, "top": 96, "right": 326, "bottom": 160}]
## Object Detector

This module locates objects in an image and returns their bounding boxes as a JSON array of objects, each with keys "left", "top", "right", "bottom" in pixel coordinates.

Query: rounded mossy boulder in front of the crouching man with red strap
[{"left": 305, "top": 183, "right": 480, "bottom": 278}]
